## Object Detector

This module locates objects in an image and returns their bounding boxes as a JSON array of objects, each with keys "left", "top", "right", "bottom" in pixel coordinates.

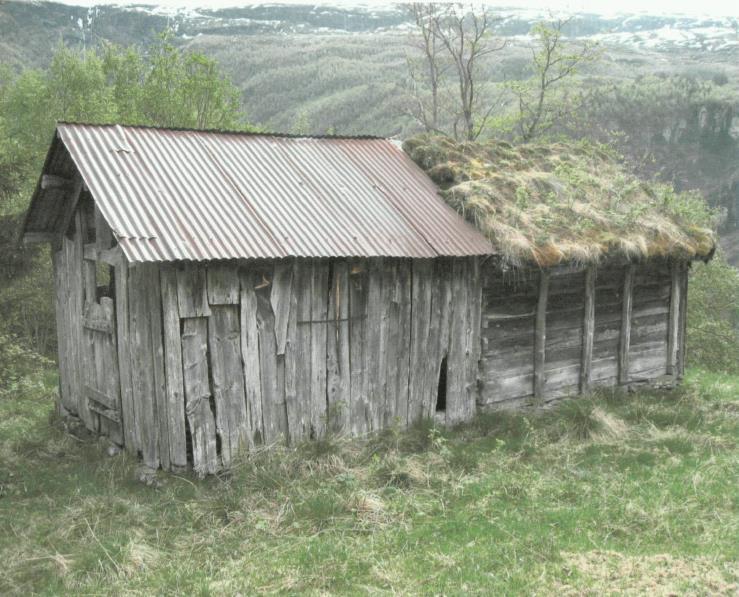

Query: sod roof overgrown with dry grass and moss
[{"left": 403, "top": 135, "right": 715, "bottom": 266}]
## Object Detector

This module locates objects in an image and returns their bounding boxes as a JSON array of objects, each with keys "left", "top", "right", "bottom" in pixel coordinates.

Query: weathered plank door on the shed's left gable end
[{"left": 82, "top": 297, "right": 123, "bottom": 445}]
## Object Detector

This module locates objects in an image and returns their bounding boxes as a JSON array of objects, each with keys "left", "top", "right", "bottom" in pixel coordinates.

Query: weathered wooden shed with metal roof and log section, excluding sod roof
[{"left": 23, "top": 124, "right": 716, "bottom": 474}]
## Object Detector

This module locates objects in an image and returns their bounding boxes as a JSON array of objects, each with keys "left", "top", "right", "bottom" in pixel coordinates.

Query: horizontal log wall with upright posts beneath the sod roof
[{"left": 479, "top": 260, "right": 687, "bottom": 409}]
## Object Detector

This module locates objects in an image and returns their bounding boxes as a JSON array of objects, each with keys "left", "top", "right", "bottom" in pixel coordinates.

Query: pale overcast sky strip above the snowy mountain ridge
[{"left": 49, "top": 0, "right": 739, "bottom": 16}]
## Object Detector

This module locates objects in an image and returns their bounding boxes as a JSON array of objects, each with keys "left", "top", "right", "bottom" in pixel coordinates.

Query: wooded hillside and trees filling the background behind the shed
[{"left": 0, "top": 3, "right": 739, "bottom": 380}]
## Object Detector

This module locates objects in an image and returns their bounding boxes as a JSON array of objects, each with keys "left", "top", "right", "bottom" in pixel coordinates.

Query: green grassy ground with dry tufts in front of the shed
[{"left": 0, "top": 371, "right": 739, "bottom": 595}]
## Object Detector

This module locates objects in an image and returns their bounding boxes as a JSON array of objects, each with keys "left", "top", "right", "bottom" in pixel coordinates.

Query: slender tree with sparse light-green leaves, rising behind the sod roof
[{"left": 511, "top": 18, "right": 600, "bottom": 141}]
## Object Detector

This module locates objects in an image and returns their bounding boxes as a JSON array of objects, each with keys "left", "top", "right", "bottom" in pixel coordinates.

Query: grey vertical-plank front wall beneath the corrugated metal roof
[{"left": 118, "top": 254, "right": 481, "bottom": 474}]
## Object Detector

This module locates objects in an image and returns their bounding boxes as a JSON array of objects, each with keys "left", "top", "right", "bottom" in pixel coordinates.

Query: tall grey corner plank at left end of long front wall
[{"left": 114, "top": 261, "right": 138, "bottom": 454}]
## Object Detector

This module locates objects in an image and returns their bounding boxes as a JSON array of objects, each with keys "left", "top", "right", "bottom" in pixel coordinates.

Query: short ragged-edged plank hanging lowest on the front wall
[{"left": 182, "top": 317, "right": 218, "bottom": 477}]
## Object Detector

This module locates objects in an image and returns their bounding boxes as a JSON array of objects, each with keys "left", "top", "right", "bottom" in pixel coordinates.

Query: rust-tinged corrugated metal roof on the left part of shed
[{"left": 28, "top": 124, "right": 492, "bottom": 262}]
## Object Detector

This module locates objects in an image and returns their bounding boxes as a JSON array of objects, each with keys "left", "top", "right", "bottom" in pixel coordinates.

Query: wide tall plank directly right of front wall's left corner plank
[{"left": 128, "top": 264, "right": 160, "bottom": 469}]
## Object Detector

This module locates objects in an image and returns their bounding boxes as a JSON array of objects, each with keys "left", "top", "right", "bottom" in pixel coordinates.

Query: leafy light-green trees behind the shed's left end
[{"left": 0, "top": 33, "right": 250, "bottom": 353}]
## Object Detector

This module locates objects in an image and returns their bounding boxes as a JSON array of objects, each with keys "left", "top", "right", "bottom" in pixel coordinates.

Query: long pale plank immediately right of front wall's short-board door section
[{"left": 239, "top": 270, "right": 264, "bottom": 445}]
